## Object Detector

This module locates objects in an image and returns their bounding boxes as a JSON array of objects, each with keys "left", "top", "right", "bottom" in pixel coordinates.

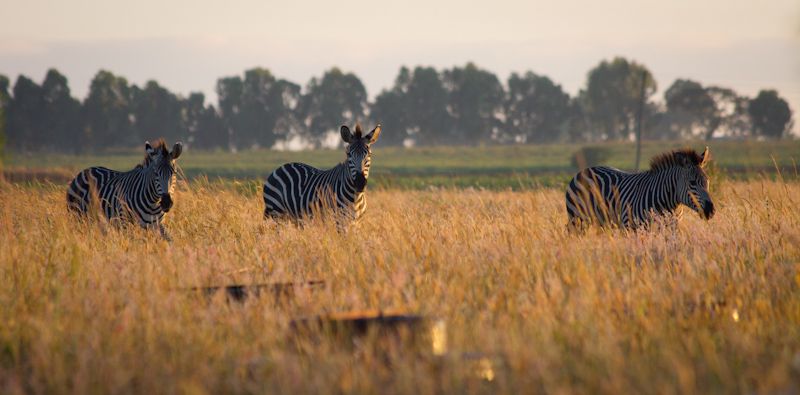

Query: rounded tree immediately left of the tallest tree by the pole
[{"left": 504, "top": 71, "right": 574, "bottom": 143}]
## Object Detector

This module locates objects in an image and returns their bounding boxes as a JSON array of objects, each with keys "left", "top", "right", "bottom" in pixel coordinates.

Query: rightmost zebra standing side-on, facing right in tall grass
[{"left": 566, "top": 147, "right": 714, "bottom": 229}]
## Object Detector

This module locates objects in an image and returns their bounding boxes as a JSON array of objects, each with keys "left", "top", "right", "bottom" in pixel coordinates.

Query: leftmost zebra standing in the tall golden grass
[{"left": 67, "top": 139, "right": 182, "bottom": 234}]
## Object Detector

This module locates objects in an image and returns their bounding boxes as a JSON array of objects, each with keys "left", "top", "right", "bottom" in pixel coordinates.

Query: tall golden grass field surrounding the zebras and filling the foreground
[{"left": 0, "top": 174, "right": 800, "bottom": 394}]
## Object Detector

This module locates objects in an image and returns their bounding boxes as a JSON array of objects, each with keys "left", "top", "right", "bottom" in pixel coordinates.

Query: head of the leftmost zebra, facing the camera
[{"left": 143, "top": 139, "right": 183, "bottom": 213}]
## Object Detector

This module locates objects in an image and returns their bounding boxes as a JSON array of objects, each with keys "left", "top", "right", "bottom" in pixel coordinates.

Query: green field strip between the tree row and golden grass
[{"left": 2, "top": 140, "right": 800, "bottom": 190}]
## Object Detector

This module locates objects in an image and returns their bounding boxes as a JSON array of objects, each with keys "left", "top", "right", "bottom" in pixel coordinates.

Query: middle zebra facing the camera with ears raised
[{"left": 264, "top": 124, "right": 381, "bottom": 222}]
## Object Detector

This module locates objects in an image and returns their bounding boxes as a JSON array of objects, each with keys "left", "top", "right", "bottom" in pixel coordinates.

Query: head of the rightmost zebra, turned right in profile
[{"left": 675, "top": 147, "right": 714, "bottom": 219}]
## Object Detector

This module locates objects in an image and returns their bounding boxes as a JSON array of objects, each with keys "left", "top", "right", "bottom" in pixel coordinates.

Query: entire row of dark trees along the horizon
[{"left": 0, "top": 57, "right": 793, "bottom": 154}]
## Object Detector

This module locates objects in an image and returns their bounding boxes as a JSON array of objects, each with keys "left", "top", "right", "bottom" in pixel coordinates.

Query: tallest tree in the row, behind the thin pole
[{"left": 580, "top": 57, "right": 657, "bottom": 140}]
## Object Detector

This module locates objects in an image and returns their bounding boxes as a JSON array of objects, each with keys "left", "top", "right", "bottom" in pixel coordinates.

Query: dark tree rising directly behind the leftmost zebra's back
[{"left": 83, "top": 70, "right": 134, "bottom": 150}]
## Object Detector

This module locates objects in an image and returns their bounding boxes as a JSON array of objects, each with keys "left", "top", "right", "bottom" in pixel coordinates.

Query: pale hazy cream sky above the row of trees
[{"left": 0, "top": 0, "right": 800, "bottom": 133}]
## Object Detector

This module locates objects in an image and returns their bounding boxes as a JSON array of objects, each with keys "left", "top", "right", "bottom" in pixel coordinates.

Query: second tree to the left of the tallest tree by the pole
[{"left": 443, "top": 62, "right": 505, "bottom": 145}]
